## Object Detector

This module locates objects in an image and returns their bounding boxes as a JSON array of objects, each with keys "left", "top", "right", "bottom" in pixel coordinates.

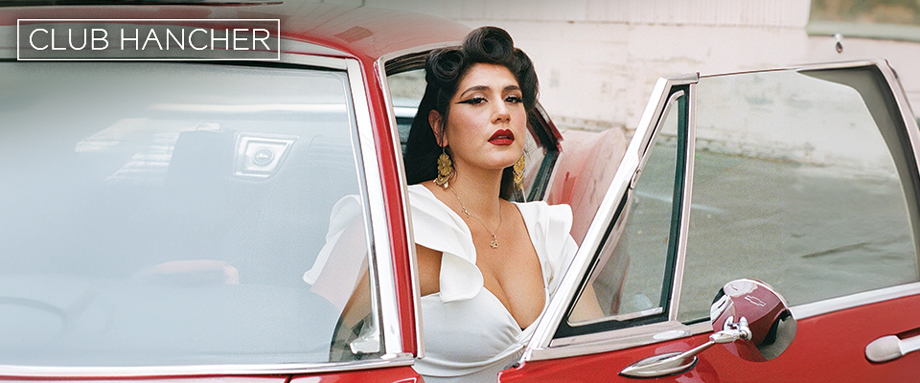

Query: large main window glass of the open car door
[{"left": 678, "top": 69, "right": 918, "bottom": 322}]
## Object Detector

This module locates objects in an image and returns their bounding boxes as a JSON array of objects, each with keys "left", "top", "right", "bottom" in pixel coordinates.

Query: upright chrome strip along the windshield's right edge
[{"left": 345, "top": 59, "right": 403, "bottom": 354}]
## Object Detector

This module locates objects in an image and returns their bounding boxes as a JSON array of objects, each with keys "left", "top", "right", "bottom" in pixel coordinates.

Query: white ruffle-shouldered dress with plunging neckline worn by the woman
[{"left": 409, "top": 185, "right": 577, "bottom": 383}]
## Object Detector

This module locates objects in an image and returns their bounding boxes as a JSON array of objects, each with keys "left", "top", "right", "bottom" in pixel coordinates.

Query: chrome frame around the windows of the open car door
[{"left": 522, "top": 59, "right": 920, "bottom": 361}]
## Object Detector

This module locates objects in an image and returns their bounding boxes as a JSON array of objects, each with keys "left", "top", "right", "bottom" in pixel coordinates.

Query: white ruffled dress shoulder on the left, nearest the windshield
[{"left": 409, "top": 185, "right": 486, "bottom": 303}]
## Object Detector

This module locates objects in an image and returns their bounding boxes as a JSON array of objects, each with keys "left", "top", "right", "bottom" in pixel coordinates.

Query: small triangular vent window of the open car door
[{"left": 562, "top": 89, "right": 688, "bottom": 333}]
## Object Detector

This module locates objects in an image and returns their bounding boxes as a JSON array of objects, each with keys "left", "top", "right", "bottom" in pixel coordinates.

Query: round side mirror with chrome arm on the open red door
[{"left": 620, "top": 279, "right": 796, "bottom": 378}]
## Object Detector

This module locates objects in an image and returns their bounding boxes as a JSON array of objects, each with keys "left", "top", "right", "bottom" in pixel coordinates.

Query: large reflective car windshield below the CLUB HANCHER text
[{"left": 0, "top": 62, "right": 381, "bottom": 367}]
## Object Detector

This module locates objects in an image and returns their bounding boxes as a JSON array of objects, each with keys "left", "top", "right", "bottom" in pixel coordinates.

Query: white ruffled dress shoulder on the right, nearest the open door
[{"left": 515, "top": 201, "right": 578, "bottom": 294}]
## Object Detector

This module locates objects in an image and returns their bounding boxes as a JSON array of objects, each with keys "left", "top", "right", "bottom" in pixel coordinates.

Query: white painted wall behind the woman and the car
[{"left": 312, "top": 0, "right": 920, "bottom": 134}]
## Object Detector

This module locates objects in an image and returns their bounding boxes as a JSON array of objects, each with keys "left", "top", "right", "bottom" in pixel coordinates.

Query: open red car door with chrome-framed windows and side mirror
[{"left": 499, "top": 61, "right": 920, "bottom": 382}]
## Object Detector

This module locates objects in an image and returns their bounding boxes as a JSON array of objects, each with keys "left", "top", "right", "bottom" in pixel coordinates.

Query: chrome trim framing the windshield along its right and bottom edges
[{"left": 0, "top": 48, "right": 415, "bottom": 379}]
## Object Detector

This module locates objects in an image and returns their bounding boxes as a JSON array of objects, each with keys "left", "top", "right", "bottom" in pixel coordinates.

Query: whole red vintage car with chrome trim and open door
[{"left": 0, "top": 3, "right": 920, "bottom": 383}]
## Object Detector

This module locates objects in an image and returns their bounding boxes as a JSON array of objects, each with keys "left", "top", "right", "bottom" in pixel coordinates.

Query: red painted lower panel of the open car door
[{"left": 500, "top": 294, "right": 920, "bottom": 383}]
